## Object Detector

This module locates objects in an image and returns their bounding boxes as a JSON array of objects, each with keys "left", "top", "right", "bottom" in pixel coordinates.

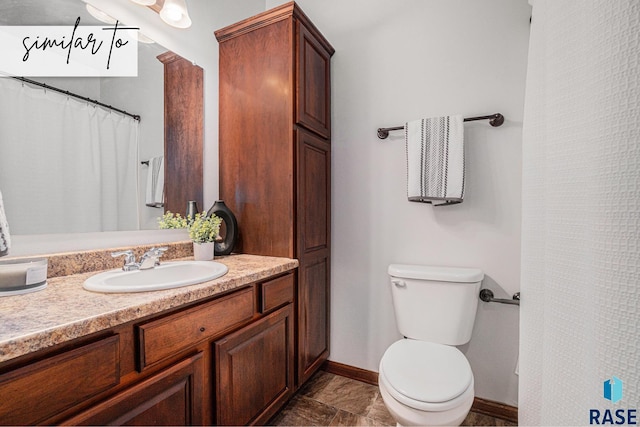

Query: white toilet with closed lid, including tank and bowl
[{"left": 379, "top": 264, "right": 484, "bottom": 426}]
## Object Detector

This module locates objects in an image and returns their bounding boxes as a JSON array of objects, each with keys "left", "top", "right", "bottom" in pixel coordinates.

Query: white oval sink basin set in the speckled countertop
[{"left": 82, "top": 261, "right": 229, "bottom": 293}]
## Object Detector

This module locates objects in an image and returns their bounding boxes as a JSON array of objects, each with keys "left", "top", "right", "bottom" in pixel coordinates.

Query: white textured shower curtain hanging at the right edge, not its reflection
[{"left": 519, "top": 0, "right": 640, "bottom": 425}]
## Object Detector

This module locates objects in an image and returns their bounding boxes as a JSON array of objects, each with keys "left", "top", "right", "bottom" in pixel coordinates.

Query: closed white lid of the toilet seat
[{"left": 380, "top": 339, "right": 473, "bottom": 403}]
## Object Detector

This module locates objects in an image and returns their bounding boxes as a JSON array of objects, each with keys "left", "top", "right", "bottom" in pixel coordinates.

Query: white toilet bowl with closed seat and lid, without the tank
[{"left": 378, "top": 339, "right": 474, "bottom": 426}]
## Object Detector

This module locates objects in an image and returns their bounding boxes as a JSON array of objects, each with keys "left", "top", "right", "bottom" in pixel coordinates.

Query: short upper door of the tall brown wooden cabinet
[{"left": 296, "top": 21, "right": 331, "bottom": 138}]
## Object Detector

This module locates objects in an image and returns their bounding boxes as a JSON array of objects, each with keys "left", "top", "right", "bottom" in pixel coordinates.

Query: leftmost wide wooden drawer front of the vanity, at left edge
[{"left": 0, "top": 335, "right": 120, "bottom": 425}]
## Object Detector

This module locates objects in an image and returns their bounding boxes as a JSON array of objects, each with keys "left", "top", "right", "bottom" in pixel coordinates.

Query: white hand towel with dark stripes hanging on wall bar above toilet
[{"left": 405, "top": 115, "right": 464, "bottom": 205}]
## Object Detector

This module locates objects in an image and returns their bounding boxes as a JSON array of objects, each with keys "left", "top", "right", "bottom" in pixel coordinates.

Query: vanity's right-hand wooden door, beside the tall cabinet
[{"left": 215, "top": 305, "right": 294, "bottom": 425}]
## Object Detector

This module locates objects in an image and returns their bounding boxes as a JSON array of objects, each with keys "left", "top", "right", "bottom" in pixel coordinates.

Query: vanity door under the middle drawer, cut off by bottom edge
[{"left": 65, "top": 353, "right": 205, "bottom": 426}]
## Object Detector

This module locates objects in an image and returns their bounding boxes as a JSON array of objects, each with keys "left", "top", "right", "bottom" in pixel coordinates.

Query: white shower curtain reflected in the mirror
[{"left": 0, "top": 78, "right": 138, "bottom": 234}]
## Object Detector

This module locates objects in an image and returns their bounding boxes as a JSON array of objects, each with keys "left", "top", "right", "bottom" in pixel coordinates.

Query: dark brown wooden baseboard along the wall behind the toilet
[{"left": 322, "top": 360, "right": 518, "bottom": 424}]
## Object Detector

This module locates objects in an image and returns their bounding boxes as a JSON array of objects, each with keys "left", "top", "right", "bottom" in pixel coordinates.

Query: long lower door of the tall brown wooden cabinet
[{"left": 297, "top": 129, "right": 331, "bottom": 384}]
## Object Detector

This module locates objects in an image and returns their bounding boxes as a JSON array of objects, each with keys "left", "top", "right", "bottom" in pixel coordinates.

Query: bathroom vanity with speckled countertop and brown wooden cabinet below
[{"left": 0, "top": 255, "right": 298, "bottom": 425}]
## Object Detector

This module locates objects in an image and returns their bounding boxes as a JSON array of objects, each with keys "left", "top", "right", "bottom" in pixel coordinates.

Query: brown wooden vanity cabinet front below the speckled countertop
[{"left": 0, "top": 272, "right": 295, "bottom": 425}]
